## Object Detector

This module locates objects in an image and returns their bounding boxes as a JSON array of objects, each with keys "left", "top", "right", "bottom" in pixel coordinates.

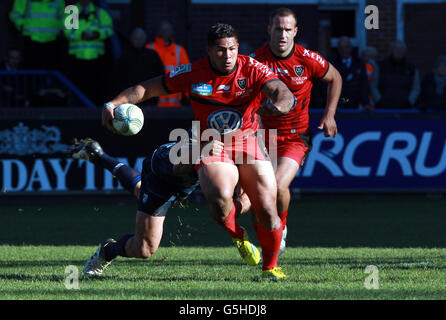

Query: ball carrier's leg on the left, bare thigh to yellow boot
[{"left": 198, "top": 162, "right": 260, "bottom": 266}]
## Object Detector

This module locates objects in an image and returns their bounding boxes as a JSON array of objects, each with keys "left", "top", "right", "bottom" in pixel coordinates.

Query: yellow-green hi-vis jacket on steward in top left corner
[{"left": 9, "top": 0, "right": 65, "bottom": 42}]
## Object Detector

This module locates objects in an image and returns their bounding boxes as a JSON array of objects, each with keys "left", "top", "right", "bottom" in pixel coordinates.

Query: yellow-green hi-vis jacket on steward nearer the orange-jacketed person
[{"left": 64, "top": 1, "right": 113, "bottom": 60}]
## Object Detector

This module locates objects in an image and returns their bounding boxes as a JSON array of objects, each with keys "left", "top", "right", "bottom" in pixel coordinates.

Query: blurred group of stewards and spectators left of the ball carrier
[{"left": 0, "top": 0, "right": 189, "bottom": 107}]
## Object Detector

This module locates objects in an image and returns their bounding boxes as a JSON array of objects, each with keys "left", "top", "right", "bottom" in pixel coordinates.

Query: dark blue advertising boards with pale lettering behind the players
[{"left": 0, "top": 107, "right": 446, "bottom": 197}]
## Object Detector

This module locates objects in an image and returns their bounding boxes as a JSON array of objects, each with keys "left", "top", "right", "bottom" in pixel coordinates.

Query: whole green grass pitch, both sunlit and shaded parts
[{"left": 0, "top": 195, "right": 446, "bottom": 300}]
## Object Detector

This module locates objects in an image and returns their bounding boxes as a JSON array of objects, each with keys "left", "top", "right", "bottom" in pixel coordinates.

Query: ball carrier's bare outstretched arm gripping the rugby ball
[{"left": 102, "top": 76, "right": 168, "bottom": 132}]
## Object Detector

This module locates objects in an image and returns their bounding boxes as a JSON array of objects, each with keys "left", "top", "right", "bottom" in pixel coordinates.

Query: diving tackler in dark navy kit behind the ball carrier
[{"left": 71, "top": 138, "right": 223, "bottom": 275}]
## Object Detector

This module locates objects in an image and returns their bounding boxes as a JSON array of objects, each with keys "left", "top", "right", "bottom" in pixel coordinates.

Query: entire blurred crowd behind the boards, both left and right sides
[{"left": 0, "top": 0, "right": 446, "bottom": 112}]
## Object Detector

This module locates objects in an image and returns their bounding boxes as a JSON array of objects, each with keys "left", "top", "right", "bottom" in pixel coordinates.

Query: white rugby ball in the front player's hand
[{"left": 113, "top": 103, "right": 144, "bottom": 136}]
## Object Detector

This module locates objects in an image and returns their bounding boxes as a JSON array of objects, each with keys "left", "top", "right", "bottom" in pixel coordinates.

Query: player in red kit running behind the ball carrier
[{"left": 254, "top": 8, "right": 342, "bottom": 251}]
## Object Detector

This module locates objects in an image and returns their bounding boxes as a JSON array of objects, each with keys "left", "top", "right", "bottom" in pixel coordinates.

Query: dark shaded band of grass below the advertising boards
[{"left": 0, "top": 195, "right": 446, "bottom": 248}]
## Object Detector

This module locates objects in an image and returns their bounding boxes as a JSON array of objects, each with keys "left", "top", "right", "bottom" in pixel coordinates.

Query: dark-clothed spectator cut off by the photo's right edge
[{"left": 419, "top": 56, "right": 446, "bottom": 111}]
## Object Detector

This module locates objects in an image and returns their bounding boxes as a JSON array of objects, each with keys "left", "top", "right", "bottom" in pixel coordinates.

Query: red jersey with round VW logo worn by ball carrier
[{"left": 164, "top": 55, "right": 277, "bottom": 135}]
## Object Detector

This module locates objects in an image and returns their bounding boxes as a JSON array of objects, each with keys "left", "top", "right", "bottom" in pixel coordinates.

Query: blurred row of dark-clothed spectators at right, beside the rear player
[{"left": 315, "top": 36, "right": 446, "bottom": 112}]
